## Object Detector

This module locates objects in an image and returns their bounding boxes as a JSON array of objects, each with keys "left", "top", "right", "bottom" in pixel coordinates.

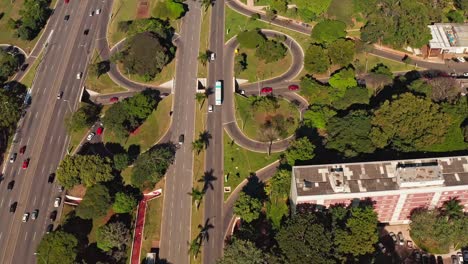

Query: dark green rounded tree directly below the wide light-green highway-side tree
[{"left": 76, "top": 184, "right": 111, "bottom": 219}]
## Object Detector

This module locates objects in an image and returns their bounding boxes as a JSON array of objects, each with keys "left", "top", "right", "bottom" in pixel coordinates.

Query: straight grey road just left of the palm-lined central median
[{"left": 160, "top": 1, "right": 201, "bottom": 264}]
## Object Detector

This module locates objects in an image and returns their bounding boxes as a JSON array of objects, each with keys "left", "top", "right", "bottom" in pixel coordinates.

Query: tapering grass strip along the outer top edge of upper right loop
[{"left": 225, "top": 7, "right": 311, "bottom": 59}]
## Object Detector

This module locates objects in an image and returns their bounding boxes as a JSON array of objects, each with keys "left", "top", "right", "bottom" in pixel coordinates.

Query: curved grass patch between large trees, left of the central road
[{"left": 104, "top": 95, "right": 172, "bottom": 152}]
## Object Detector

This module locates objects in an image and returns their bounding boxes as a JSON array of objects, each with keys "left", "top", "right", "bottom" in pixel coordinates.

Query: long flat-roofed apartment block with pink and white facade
[{"left": 290, "top": 156, "right": 468, "bottom": 224}]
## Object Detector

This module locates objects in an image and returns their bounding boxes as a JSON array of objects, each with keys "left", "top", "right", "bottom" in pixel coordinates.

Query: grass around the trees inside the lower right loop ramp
[{"left": 234, "top": 95, "right": 300, "bottom": 141}]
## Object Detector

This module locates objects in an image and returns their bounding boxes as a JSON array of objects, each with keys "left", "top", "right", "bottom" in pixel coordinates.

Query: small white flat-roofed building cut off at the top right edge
[{"left": 427, "top": 23, "right": 468, "bottom": 57}]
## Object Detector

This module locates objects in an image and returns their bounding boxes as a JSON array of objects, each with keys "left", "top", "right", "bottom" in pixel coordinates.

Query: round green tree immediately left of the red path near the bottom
[{"left": 96, "top": 222, "right": 130, "bottom": 252}]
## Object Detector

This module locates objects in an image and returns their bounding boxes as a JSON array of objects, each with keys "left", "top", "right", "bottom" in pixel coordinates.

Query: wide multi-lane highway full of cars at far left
[{"left": 0, "top": 1, "right": 111, "bottom": 263}]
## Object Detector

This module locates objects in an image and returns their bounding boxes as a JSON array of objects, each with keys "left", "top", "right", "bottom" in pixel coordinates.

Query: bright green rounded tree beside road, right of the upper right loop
[{"left": 312, "top": 20, "right": 346, "bottom": 45}]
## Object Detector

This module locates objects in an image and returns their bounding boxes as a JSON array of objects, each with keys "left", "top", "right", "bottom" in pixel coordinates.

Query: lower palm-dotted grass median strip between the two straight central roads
[{"left": 190, "top": 100, "right": 208, "bottom": 264}]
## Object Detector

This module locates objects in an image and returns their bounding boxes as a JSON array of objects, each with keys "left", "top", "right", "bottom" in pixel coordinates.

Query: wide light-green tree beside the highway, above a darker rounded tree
[{"left": 57, "top": 155, "right": 114, "bottom": 188}]
